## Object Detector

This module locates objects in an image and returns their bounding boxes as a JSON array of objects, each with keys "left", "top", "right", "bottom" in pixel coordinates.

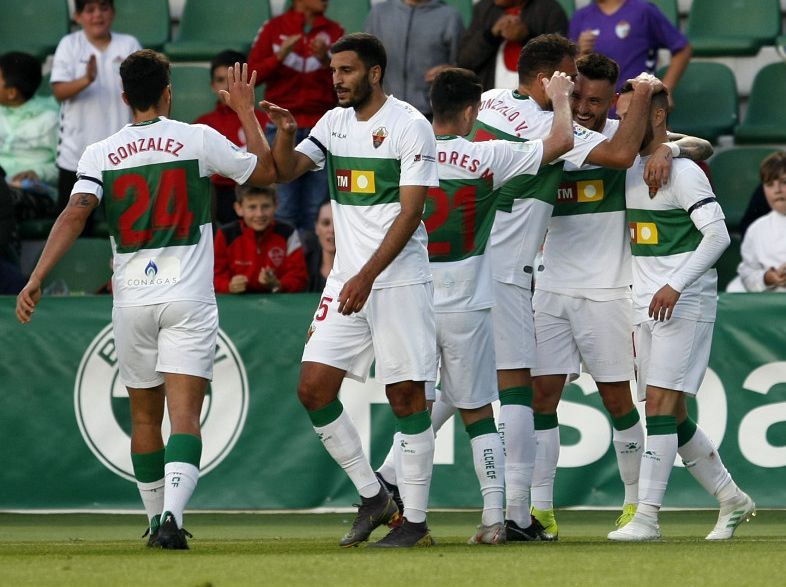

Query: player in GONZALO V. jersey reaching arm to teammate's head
[{"left": 473, "top": 35, "right": 659, "bottom": 541}]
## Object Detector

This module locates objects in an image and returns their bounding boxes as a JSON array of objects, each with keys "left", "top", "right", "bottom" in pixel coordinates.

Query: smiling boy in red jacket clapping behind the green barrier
[{"left": 214, "top": 185, "right": 308, "bottom": 294}]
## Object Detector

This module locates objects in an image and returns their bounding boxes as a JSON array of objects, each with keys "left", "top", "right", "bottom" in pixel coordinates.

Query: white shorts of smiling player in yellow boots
[{"left": 532, "top": 290, "right": 634, "bottom": 383}]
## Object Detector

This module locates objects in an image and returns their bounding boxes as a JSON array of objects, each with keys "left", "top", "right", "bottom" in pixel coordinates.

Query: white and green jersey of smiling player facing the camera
[{"left": 535, "top": 120, "right": 631, "bottom": 299}]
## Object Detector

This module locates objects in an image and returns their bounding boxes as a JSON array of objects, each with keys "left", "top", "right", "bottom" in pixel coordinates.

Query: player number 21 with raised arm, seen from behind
[{"left": 370, "top": 68, "right": 573, "bottom": 544}]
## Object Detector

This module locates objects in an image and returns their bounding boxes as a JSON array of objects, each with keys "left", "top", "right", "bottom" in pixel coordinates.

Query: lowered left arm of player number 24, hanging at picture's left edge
[{"left": 16, "top": 194, "right": 98, "bottom": 324}]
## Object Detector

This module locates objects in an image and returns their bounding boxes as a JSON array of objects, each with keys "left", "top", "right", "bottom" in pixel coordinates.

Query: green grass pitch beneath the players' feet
[{"left": 0, "top": 510, "right": 786, "bottom": 587}]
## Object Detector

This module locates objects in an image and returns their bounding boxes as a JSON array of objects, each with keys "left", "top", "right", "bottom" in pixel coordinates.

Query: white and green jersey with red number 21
[{"left": 424, "top": 136, "right": 543, "bottom": 312}]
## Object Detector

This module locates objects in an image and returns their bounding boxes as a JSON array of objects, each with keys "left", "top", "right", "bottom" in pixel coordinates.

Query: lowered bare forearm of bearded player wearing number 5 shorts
[{"left": 338, "top": 185, "right": 428, "bottom": 314}]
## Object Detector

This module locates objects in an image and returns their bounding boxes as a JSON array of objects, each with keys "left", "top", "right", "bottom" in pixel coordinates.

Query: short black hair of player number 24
[{"left": 120, "top": 49, "right": 169, "bottom": 112}]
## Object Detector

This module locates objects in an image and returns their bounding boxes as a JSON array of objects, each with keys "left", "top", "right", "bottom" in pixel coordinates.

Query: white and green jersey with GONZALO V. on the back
[{"left": 470, "top": 89, "right": 606, "bottom": 289}]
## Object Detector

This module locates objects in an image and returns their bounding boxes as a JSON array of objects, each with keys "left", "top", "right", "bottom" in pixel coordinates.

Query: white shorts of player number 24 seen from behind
[{"left": 112, "top": 301, "right": 218, "bottom": 389}]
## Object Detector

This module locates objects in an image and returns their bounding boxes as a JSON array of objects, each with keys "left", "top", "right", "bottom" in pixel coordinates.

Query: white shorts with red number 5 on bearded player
[{"left": 303, "top": 282, "right": 437, "bottom": 384}]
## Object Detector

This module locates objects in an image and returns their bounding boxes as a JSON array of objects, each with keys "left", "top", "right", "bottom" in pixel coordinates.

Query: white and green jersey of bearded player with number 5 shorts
[{"left": 297, "top": 96, "right": 439, "bottom": 289}]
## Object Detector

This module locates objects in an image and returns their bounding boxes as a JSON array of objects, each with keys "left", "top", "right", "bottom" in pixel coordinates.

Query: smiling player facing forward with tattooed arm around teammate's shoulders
[{"left": 532, "top": 53, "right": 712, "bottom": 527}]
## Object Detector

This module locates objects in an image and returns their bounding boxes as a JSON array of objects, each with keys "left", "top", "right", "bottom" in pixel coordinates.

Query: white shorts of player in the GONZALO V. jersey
[{"left": 491, "top": 280, "right": 535, "bottom": 369}]
